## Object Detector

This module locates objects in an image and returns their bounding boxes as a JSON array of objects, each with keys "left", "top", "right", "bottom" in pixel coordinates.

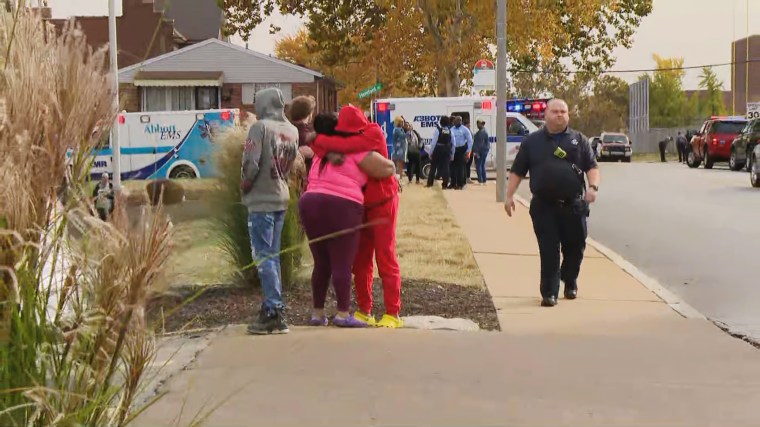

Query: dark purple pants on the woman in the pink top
[{"left": 298, "top": 192, "right": 364, "bottom": 311}]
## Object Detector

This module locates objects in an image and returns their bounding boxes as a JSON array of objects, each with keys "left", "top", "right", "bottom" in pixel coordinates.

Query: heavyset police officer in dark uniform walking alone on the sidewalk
[{"left": 504, "top": 99, "right": 599, "bottom": 307}]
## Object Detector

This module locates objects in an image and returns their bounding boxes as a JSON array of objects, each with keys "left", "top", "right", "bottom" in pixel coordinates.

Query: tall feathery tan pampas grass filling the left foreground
[{"left": 0, "top": 10, "right": 171, "bottom": 426}]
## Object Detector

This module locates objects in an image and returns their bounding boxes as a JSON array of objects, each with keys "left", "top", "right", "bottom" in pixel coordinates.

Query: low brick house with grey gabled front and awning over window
[{"left": 119, "top": 38, "right": 338, "bottom": 113}]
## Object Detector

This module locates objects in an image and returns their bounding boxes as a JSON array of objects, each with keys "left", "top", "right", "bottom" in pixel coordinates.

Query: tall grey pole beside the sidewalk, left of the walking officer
[{"left": 496, "top": 0, "right": 507, "bottom": 203}]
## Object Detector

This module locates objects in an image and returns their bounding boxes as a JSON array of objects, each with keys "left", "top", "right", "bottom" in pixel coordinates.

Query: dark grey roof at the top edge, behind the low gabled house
[{"left": 153, "top": 0, "right": 222, "bottom": 41}]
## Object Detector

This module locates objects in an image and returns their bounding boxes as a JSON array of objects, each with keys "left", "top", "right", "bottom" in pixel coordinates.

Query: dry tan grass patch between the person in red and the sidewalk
[{"left": 396, "top": 185, "right": 484, "bottom": 287}]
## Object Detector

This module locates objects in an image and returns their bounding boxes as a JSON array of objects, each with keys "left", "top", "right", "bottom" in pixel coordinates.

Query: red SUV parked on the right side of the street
[{"left": 686, "top": 116, "right": 747, "bottom": 169}]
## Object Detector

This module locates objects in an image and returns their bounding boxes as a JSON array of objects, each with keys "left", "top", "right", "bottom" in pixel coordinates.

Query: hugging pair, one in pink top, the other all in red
[{"left": 299, "top": 105, "right": 403, "bottom": 328}]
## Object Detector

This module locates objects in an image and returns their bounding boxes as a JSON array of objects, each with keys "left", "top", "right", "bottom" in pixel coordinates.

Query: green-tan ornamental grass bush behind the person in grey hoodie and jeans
[{"left": 212, "top": 120, "right": 304, "bottom": 287}]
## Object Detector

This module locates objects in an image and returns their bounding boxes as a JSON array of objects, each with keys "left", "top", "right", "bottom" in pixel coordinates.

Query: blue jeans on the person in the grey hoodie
[{"left": 248, "top": 211, "right": 285, "bottom": 314}]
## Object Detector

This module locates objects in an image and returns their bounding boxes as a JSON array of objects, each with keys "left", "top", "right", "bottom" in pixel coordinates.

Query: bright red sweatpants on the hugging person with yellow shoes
[{"left": 353, "top": 196, "right": 401, "bottom": 316}]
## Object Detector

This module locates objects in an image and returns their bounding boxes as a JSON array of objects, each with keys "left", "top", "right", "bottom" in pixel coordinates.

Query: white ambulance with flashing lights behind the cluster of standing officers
[{"left": 371, "top": 96, "right": 548, "bottom": 176}]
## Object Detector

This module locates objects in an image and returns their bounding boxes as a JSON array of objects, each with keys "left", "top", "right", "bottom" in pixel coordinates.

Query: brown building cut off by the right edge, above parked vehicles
[{"left": 726, "top": 35, "right": 760, "bottom": 115}]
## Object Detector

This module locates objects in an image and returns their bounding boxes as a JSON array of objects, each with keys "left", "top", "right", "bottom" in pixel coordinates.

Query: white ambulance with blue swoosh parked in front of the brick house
[{"left": 90, "top": 109, "right": 240, "bottom": 180}]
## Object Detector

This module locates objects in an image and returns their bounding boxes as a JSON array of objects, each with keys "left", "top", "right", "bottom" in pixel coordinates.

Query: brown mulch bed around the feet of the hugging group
[{"left": 149, "top": 280, "right": 499, "bottom": 332}]
